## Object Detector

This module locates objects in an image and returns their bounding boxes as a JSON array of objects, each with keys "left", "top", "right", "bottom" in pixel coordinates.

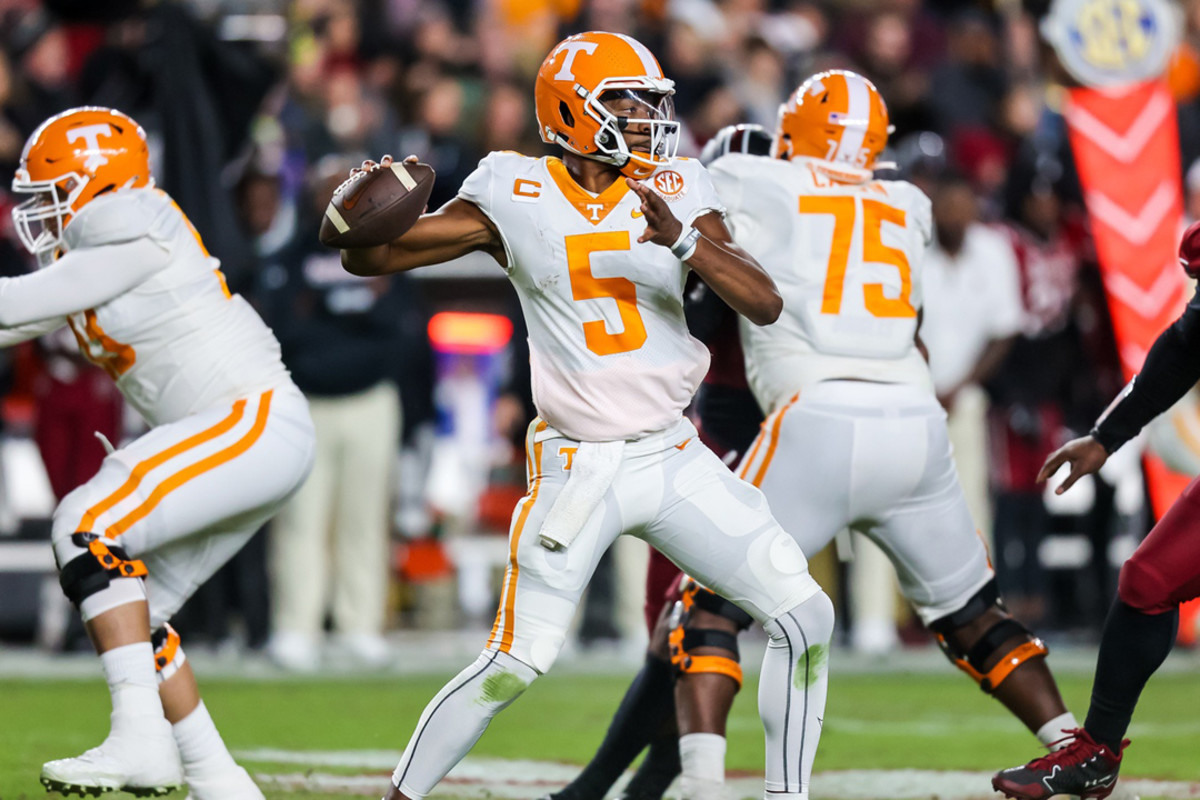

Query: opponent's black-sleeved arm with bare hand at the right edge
[{"left": 1038, "top": 295, "right": 1200, "bottom": 494}]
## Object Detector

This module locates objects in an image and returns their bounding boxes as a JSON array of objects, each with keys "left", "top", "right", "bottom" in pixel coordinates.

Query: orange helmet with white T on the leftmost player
[{"left": 12, "top": 106, "right": 154, "bottom": 255}]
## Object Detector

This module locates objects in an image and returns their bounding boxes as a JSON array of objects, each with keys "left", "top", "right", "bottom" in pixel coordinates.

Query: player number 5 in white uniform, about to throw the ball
[{"left": 342, "top": 32, "right": 833, "bottom": 800}]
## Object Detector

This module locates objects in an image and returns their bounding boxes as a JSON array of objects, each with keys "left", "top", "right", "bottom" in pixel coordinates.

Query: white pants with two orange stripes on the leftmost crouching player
[{"left": 50, "top": 383, "right": 314, "bottom": 630}]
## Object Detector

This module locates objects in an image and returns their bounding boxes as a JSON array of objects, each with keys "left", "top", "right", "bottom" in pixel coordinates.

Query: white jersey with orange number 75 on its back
[{"left": 710, "top": 154, "right": 932, "bottom": 414}]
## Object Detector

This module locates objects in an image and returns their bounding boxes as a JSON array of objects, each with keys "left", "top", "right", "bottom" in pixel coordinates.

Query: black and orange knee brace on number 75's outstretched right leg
[{"left": 929, "top": 579, "right": 1050, "bottom": 694}]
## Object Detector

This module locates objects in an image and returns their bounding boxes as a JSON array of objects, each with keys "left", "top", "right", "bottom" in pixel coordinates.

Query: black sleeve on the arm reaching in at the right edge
[{"left": 1092, "top": 294, "right": 1200, "bottom": 453}]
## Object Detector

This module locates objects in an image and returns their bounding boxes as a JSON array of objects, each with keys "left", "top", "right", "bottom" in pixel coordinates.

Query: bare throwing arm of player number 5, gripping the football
[{"left": 342, "top": 156, "right": 508, "bottom": 276}]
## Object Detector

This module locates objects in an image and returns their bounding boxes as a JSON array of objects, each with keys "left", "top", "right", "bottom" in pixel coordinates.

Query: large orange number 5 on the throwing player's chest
[{"left": 566, "top": 230, "right": 646, "bottom": 355}]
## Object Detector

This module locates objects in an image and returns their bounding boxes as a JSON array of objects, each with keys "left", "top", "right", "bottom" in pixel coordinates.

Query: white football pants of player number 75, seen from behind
[{"left": 738, "top": 380, "right": 995, "bottom": 624}]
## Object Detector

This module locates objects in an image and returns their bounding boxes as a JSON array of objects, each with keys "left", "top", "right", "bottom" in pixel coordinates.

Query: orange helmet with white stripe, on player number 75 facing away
[{"left": 772, "top": 70, "right": 893, "bottom": 184}]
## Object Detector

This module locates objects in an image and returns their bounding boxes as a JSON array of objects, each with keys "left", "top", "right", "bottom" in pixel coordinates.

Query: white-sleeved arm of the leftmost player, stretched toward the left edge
[{"left": 0, "top": 236, "right": 168, "bottom": 329}]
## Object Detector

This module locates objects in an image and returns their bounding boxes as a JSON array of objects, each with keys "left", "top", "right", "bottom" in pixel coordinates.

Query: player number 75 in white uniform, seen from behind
[{"left": 710, "top": 71, "right": 1076, "bottom": 758}]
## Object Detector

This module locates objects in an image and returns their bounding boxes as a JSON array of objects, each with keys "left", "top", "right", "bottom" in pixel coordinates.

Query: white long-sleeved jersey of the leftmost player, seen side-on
[{"left": 0, "top": 188, "right": 290, "bottom": 425}]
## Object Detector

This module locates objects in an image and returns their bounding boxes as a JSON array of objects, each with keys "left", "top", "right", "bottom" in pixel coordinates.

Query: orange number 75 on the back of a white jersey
[{"left": 800, "top": 194, "right": 917, "bottom": 317}]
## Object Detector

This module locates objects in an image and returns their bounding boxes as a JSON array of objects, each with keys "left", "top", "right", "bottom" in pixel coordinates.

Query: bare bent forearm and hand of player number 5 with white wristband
[{"left": 625, "top": 179, "right": 784, "bottom": 325}]
